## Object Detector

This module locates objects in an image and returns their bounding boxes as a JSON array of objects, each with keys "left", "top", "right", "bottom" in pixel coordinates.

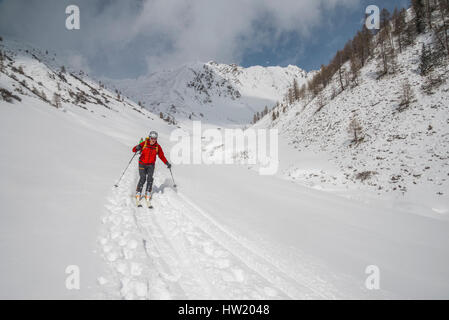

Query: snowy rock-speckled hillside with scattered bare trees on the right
[{"left": 255, "top": 13, "right": 449, "bottom": 219}]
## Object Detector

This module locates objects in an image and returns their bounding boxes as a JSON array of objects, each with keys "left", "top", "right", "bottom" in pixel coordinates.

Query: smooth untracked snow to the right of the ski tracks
[{"left": 172, "top": 139, "right": 448, "bottom": 298}]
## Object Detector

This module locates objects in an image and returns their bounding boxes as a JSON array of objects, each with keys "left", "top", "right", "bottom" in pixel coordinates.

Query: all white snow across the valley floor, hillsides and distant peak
[{"left": 0, "top": 31, "right": 449, "bottom": 299}]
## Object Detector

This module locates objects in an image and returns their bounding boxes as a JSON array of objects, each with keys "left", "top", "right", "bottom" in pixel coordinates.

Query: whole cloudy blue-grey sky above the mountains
[{"left": 0, "top": 0, "right": 409, "bottom": 79}]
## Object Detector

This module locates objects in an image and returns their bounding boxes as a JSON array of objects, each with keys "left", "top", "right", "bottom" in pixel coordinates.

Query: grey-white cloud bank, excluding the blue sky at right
[{"left": 0, "top": 0, "right": 359, "bottom": 77}]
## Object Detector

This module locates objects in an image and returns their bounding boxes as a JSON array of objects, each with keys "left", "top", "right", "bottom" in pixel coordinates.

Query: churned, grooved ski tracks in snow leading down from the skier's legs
[{"left": 98, "top": 165, "right": 335, "bottom": 299}]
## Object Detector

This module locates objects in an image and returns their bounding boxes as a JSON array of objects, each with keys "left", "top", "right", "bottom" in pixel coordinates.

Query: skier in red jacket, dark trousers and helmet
[{"left": 133, "top": 131, "right": 171, "bottom": 200}]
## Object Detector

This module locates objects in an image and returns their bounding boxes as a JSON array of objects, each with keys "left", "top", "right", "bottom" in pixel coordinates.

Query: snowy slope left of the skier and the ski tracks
[{"left": 0, "top": 40, "right": 170, "bottom": 298}]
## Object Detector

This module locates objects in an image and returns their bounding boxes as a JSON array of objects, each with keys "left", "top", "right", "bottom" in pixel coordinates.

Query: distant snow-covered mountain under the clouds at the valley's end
[{"left": 104, "top": 62, "right": 308, "bottom": 125}]
